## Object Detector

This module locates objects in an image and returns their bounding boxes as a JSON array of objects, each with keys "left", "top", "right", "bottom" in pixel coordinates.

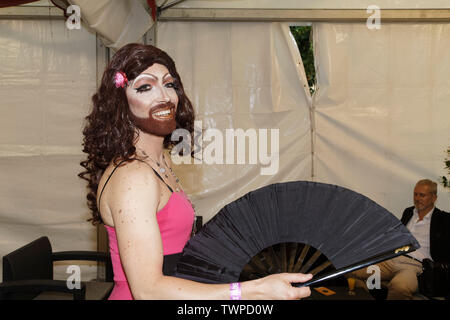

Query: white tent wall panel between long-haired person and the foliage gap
[{"left": 158, "top": 22, "right": 311, "bottom": 220}]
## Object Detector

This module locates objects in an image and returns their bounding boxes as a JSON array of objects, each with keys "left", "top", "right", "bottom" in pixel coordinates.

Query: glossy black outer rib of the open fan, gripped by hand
[{"left": 292, "top": 245, "right": 415, "bottom": 288}]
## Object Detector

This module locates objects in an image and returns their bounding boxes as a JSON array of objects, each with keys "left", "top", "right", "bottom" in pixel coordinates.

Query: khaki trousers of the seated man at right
[{"left": 347, "top": 256, "right": 422, "bottom": 300}]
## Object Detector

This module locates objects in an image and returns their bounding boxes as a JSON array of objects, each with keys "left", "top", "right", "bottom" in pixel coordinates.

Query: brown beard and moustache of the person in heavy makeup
[{"left": 130, "top": 102, "right": 177, "bottom": 137}]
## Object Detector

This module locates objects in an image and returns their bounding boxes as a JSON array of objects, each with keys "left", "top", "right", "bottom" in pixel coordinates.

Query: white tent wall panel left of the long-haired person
[{"left": 0, "top": 20, "right": 97, "bottom": 279}]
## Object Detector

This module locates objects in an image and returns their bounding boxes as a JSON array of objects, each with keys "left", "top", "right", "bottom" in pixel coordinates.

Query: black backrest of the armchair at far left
[{"left": 3, "top": 237, "right": 53, "bottom": 282}]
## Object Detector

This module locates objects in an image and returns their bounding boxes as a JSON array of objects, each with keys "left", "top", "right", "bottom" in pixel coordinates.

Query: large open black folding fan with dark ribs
[{"left": 175, "top": 181, "right": 419, "bottom": 286}]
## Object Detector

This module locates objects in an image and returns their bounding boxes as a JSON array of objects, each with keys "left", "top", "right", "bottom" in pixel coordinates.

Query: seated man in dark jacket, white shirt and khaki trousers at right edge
[{"left": 348, "top": 179, "right": 450, "bottom": 300}]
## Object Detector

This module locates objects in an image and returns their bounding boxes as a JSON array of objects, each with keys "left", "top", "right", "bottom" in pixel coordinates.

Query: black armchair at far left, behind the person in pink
[{"left": 0, "top": 237, "right": 114, "bottom": 300}]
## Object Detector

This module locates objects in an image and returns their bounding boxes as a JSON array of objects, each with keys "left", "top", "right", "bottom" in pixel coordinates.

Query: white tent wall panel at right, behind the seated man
[{"left": 313, "top": 23, "right": 450, "bottom": 217}]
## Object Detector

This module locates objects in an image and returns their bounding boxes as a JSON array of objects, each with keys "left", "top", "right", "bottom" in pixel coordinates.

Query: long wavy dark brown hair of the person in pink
[{"left": 78, "top": 43, "right": 195, "bottom": 225}]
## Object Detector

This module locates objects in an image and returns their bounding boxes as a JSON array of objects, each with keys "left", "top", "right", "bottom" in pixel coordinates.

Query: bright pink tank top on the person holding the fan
[{"left": 105, "top": 191, "right": 194, "bottom": 300}]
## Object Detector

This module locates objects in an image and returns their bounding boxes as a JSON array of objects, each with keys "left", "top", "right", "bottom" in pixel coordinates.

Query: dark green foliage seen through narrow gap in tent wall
[{"left": 290, "top": 26, "right": 316, "bottom": 94}]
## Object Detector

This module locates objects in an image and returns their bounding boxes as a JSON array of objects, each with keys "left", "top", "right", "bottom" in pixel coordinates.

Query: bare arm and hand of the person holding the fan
[{"left": 108, "top": 162, "right": 311, "bottom": 300}]
